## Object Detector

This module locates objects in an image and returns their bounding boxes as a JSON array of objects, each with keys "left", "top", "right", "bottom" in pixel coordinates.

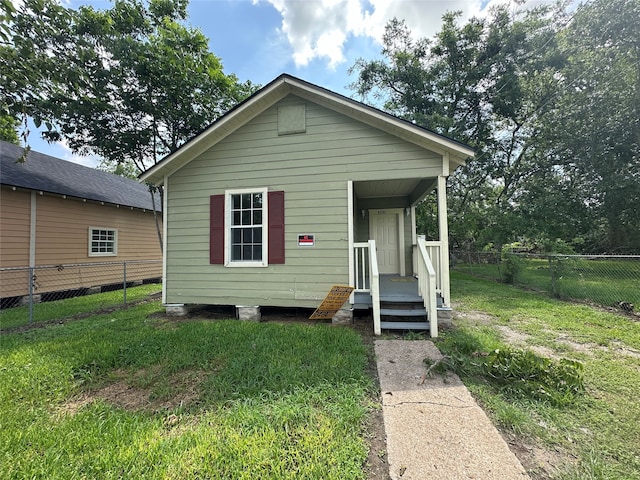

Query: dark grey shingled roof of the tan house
[{"left": 0, "top": 141, "right": 161, "bottom": 210}]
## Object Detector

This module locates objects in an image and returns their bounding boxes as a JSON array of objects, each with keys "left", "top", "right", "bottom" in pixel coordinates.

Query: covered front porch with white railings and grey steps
[{"left": 349, "top": 175, "right": 450, "bottom": 337}]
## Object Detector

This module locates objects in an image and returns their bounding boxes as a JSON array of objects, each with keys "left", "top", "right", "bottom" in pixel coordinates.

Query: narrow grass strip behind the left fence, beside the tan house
[{"left": 0, "top": 284, "right": 162, "bottom": 330}]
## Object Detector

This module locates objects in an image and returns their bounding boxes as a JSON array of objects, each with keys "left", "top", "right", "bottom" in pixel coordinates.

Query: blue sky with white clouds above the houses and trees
[{"left": 29, "top": 0, "right": 549, "bottom": 167}]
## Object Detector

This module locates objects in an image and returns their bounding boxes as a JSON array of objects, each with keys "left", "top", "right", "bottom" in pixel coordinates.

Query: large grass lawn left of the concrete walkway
[{"left": 0, "top": 303, "right": 374, "bottom": 479}]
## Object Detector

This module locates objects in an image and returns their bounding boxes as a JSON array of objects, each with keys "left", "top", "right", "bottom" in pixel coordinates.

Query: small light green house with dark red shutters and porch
[{"left": 141, "top": 75, "right": 473, "bottom": 336}]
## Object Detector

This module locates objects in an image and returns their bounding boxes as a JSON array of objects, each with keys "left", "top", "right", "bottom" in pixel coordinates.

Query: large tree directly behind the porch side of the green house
[{"left": 353, "top": 5, "right": 624, "bottom": 248}]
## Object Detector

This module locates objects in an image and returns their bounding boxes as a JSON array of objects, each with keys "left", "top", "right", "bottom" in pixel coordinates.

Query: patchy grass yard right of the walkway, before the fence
[{"left": 438, "top": 273, "right": 640, "bottom": 479}]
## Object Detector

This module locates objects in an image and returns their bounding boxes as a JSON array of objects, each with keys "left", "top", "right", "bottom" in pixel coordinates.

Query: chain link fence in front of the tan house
[{"left": 0, "top": 260, "right": 162, "bottom": 329}]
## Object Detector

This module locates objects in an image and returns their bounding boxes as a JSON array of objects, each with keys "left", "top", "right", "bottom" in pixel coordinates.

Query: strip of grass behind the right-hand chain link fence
[{"left": 456, "top": 255, "right": 640, "bottom": 309}]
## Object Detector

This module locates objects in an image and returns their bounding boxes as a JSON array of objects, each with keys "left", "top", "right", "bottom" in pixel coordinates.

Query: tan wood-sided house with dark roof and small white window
[{"left": 0, "top": 142, "right": 162, "bottom": 305}]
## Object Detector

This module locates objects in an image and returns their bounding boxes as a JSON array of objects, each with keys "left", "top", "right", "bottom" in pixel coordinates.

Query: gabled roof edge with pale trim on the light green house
[{"left": 140, "top": 74, "right": 473, "bottom": 185}]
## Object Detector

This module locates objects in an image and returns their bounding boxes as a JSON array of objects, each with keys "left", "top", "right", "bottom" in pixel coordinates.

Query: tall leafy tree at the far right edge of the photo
[{"left": 543, "top": 0, "right": 640, "bottom": 253}]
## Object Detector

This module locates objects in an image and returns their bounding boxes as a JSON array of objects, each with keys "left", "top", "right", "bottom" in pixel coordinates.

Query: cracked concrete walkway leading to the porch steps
[{"left": 375, "top": 340, "right": 529, "bottom": 480}]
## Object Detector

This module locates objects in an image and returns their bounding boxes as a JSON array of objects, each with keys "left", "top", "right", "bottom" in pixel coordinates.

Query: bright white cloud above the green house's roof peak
[{"left": 254, "top": 0, "right": 549, "bottom": 69}]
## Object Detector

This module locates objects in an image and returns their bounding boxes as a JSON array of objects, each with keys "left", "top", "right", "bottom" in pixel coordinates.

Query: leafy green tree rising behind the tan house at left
[{"left": 0, "top": 0, "right": 256, "bottom": 251}]
